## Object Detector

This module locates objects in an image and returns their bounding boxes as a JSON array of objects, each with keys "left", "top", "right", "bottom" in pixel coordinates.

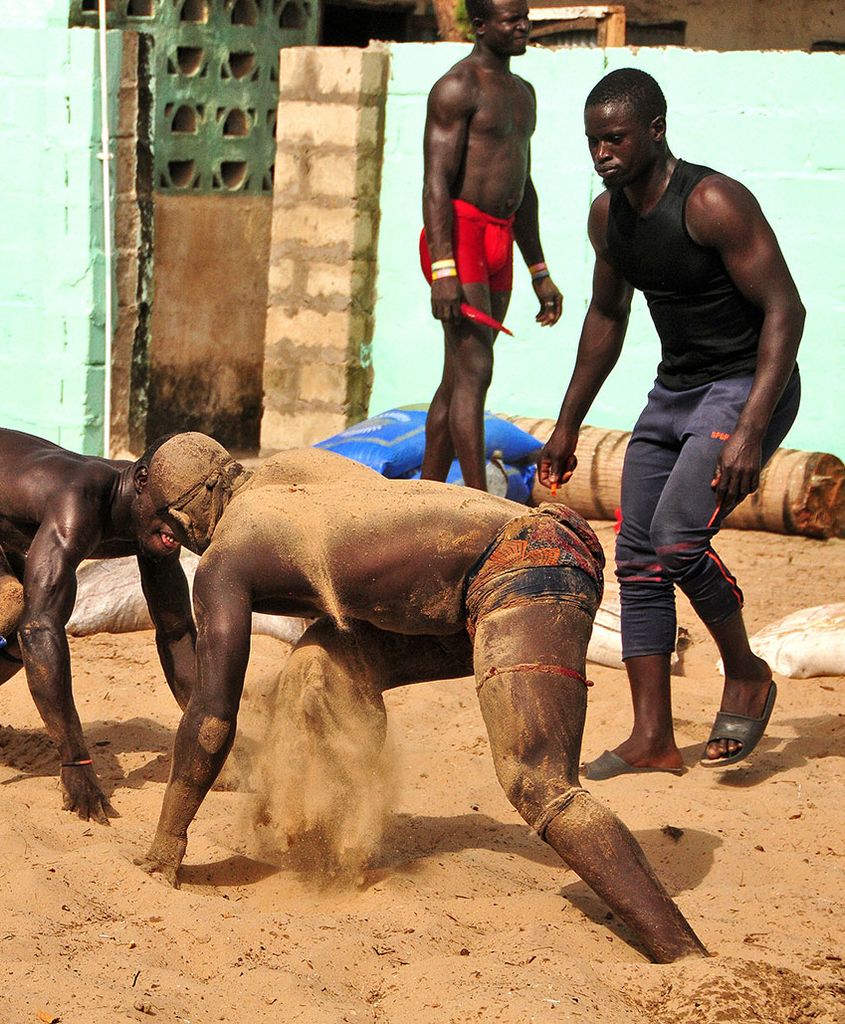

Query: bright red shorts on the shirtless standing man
[{"left": 420, "top": 199, "right": 513, "bottom": 292}]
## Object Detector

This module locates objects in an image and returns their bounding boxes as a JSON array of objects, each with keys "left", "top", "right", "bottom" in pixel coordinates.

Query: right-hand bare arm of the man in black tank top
[{"left": 686, "top": 175, "right": 805, "bottom": 506}]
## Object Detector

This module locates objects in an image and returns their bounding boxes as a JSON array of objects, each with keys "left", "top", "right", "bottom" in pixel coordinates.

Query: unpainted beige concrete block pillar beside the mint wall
[{"left": 261, "top": 47, "right": 387, "bottom": 453}]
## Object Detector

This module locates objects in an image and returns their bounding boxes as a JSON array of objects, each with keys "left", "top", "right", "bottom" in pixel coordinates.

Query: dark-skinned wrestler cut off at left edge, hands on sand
[{"left": 0, "top": 430, "right": 207, "bottom": 824}]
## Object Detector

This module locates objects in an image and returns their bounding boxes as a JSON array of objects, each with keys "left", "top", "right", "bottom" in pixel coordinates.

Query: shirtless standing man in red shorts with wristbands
[{"left": 420, "top": 0, "right": 563, "bottom": 490}]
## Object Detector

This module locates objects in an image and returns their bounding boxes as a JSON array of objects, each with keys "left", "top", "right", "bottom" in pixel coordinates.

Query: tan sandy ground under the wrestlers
[{"left": 0, "top": 523, "right": 845, "bottom": 1024}]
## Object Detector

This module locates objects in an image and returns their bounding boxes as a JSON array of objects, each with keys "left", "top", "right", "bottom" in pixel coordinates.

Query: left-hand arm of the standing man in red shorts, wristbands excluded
[{"left": 423, "top": 72, "right": 476, "bottom": 323}]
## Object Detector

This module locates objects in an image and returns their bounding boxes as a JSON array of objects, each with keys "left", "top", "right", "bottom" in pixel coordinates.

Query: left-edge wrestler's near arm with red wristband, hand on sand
[{"left": 18, "top": 488, "right": 116, "bottom": 824}]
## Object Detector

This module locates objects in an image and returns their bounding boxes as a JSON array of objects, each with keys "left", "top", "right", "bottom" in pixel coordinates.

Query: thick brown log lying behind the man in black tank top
[{"left": 500, "top": 414, "right": 845, "bottom": 538}]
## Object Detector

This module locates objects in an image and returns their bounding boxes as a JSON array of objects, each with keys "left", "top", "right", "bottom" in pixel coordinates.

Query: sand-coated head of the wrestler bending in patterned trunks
[{"left": 144, "top": 432, "right": 250, "bottom": 554}]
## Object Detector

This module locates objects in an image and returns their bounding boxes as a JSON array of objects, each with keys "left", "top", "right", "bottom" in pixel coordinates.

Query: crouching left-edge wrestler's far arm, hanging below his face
[{"left": 138, "top": 554, "right": 197, "bottom": 711}]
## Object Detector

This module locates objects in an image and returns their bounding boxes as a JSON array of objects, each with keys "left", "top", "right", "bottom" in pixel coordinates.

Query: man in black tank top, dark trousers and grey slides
[{"left": 540, "top": 68, "right": 804, "bottom": 779}]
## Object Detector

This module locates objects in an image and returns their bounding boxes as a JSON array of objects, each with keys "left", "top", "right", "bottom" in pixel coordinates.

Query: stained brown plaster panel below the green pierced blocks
[{"left": 146, "top": 194, "right": 272, "bottom": 452}]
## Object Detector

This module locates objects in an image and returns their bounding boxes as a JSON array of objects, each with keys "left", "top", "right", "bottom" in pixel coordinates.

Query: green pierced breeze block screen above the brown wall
[{"left": 70, "top": 0, "right": 320, "bottom": 195}]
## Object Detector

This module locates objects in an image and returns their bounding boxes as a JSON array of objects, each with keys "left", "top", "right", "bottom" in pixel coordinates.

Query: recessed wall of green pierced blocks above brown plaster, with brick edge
[{"left": 108, "top": 3, "right": 292, "bottom": 454}]
